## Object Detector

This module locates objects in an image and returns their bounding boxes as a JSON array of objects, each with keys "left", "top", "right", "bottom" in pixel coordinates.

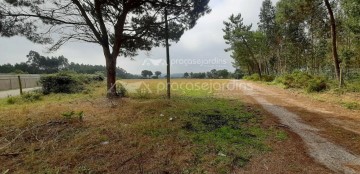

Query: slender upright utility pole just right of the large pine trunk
[{"left": 165, "top": 4, "right": 171, "bottom": 99}]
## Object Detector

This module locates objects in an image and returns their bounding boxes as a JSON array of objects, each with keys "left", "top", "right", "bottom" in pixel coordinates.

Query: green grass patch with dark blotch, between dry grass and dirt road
[{"left": 162, "top": 98, "right": 269, "bottom": 173}]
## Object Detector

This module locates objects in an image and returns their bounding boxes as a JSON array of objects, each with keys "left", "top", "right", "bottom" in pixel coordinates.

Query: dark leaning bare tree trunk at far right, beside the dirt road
[{"left": 324, "top": 0, "right": 343, "bottom": 86}]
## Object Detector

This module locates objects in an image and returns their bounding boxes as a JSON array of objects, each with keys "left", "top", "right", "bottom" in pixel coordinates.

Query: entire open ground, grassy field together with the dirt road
[{"left": 4, "top": 79, "right": 360, "bottom": 174}]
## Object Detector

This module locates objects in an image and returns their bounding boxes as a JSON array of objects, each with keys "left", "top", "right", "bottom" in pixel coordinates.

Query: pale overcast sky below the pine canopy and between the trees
[{"left": 0, "top": 0, "right": 278, "bottom": 74}]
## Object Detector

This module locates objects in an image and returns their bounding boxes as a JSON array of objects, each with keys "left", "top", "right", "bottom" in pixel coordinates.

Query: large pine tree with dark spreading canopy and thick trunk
[{"left": 0, "top": 0, "right": 210, "bottom": 94}]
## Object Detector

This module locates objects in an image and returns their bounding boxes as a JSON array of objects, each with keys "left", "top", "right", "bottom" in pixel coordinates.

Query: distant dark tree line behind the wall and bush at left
[{"left": 0, "top": 51, "right": 139, "bottom": 79}]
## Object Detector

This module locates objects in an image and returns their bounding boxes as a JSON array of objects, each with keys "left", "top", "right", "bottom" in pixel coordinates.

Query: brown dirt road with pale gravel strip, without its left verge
[{"left": 224, "top": 81, "right": 360, "bottom": 173}]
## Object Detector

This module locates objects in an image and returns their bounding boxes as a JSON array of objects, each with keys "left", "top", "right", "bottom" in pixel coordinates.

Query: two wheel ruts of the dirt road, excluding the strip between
[{"left": 230, "top": 81, "right": 360, "bottom": 173}]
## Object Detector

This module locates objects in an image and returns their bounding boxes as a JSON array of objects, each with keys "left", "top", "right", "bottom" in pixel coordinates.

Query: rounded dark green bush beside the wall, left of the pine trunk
[{"left": 40, "top": 72, "right": 86, "bottom": 94}]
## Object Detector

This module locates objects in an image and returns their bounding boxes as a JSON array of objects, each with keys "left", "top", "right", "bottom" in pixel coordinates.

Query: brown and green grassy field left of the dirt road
[{"left": 0, "top": 80, "right": 286, "bottom": 173}]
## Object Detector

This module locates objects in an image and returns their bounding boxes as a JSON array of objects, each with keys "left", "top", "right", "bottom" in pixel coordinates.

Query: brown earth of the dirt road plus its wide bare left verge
[{"left": 217, "top": 81, "right": 360, "bottom": 173}]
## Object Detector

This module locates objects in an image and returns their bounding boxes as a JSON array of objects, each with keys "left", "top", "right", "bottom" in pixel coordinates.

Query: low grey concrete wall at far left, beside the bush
[{"left": 0, "top": 74, "right": 40, "bottom": 91}]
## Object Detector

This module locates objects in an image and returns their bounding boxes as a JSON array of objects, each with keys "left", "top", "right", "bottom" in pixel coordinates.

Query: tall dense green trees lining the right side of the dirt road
[{"left": 223, "top": 0, "right": 360, "bottom": 84}]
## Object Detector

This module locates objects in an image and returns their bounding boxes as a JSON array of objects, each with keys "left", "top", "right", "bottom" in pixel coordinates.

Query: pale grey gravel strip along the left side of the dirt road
[{"left": 231, "top": 81, "right": 360, "bottom": 174}]
